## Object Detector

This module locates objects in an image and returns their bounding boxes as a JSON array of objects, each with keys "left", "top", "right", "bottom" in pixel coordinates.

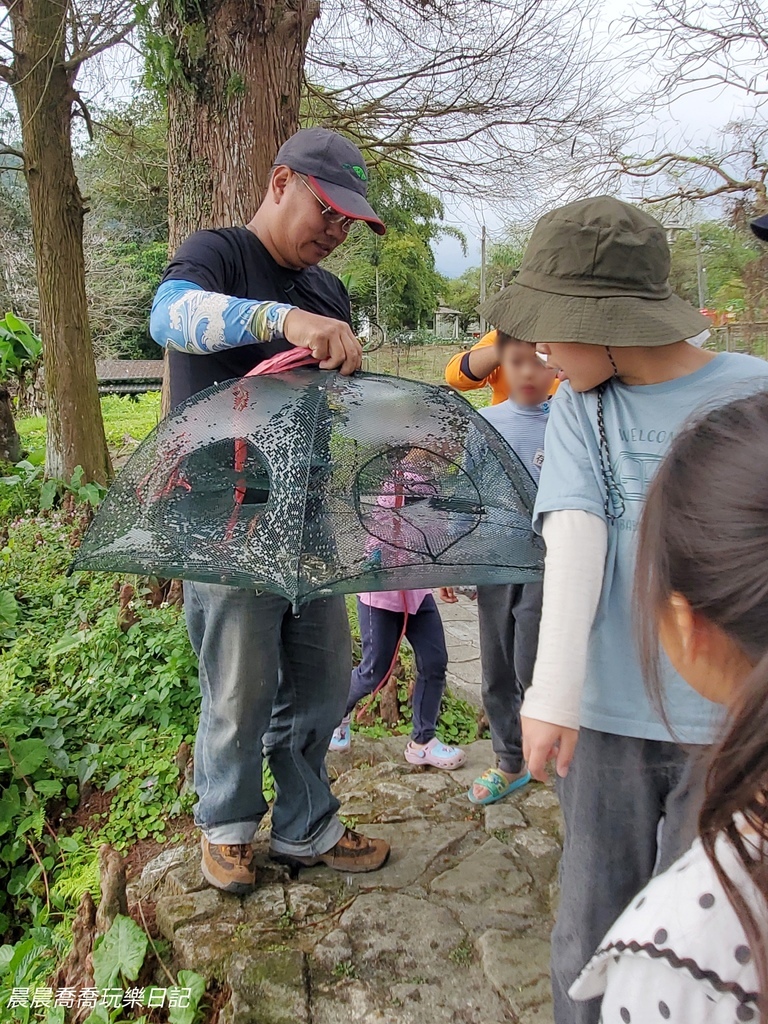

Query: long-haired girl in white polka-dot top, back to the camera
[{"left": 570, "top": 393, "right": 768, "bottom": 1024}]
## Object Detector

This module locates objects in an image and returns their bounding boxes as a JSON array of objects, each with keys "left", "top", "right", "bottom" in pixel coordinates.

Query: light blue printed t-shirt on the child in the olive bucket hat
[{"left": 534, "top": 352, "right": 768, "bottom": 743}]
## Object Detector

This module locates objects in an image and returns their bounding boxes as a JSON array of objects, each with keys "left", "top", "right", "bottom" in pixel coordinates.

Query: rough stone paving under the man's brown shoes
[{"left": 129, "top": 736, "right": 561, "bottom": 1024}]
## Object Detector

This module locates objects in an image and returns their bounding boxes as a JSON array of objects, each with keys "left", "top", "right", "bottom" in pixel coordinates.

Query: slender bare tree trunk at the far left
[{"left": 9, "top": 0, "right": 112, "bottom": 483}]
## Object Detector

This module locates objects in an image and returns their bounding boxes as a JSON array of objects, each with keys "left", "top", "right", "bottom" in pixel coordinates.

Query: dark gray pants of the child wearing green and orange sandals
[{"left": 477, "top": 583, "right": 543, "bottom": 775}]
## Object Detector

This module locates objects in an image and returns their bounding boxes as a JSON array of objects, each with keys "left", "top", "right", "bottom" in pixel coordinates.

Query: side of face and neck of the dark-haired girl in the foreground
[{"left": 658, "top": 594, "right": 753, "bottom": 707}]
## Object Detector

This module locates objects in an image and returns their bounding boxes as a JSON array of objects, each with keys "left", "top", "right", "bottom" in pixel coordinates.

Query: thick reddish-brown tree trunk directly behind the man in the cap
[{"left": 161, "top": 0, "right": 319, "bottom": 250}]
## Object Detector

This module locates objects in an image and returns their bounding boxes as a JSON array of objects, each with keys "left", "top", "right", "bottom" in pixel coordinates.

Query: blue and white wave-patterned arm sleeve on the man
[{"left": 150, "top": 281, "right": 296, "bottom": 355}]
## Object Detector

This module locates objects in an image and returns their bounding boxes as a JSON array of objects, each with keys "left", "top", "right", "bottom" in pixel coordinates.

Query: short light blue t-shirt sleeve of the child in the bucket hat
[{"left": 534, "top": 383, "right": 605, "bottom": 534}]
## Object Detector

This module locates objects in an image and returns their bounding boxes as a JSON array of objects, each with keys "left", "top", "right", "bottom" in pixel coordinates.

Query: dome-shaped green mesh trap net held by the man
[{"left": 74, "top": 370, "right": 543, "bottom": 607}]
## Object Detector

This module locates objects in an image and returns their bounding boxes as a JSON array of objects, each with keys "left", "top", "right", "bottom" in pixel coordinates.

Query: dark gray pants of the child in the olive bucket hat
[{"left": 552, "top": 728, "right": 705, "bottom": 1024}]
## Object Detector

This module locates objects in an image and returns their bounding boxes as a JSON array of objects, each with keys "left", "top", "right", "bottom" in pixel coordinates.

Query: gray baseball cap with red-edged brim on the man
[{"left": 274, "top": 128, "right": 386, "bottom": 234}]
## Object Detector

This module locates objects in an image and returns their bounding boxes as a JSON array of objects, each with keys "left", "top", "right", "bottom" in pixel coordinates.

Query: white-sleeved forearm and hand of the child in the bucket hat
[{"left": 521, "top": 510, "right": 608, "bottom": 780}]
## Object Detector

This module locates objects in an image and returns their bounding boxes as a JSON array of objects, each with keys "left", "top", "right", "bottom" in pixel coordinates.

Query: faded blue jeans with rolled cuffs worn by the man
[{"left": 184, "top": 582, "right": 351, "bottom": 856}]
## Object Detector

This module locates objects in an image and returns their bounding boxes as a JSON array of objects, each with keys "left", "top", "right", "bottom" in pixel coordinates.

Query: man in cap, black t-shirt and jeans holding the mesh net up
[{"left": 150, "top": 128, "right": 389, "bottom": 893}]
